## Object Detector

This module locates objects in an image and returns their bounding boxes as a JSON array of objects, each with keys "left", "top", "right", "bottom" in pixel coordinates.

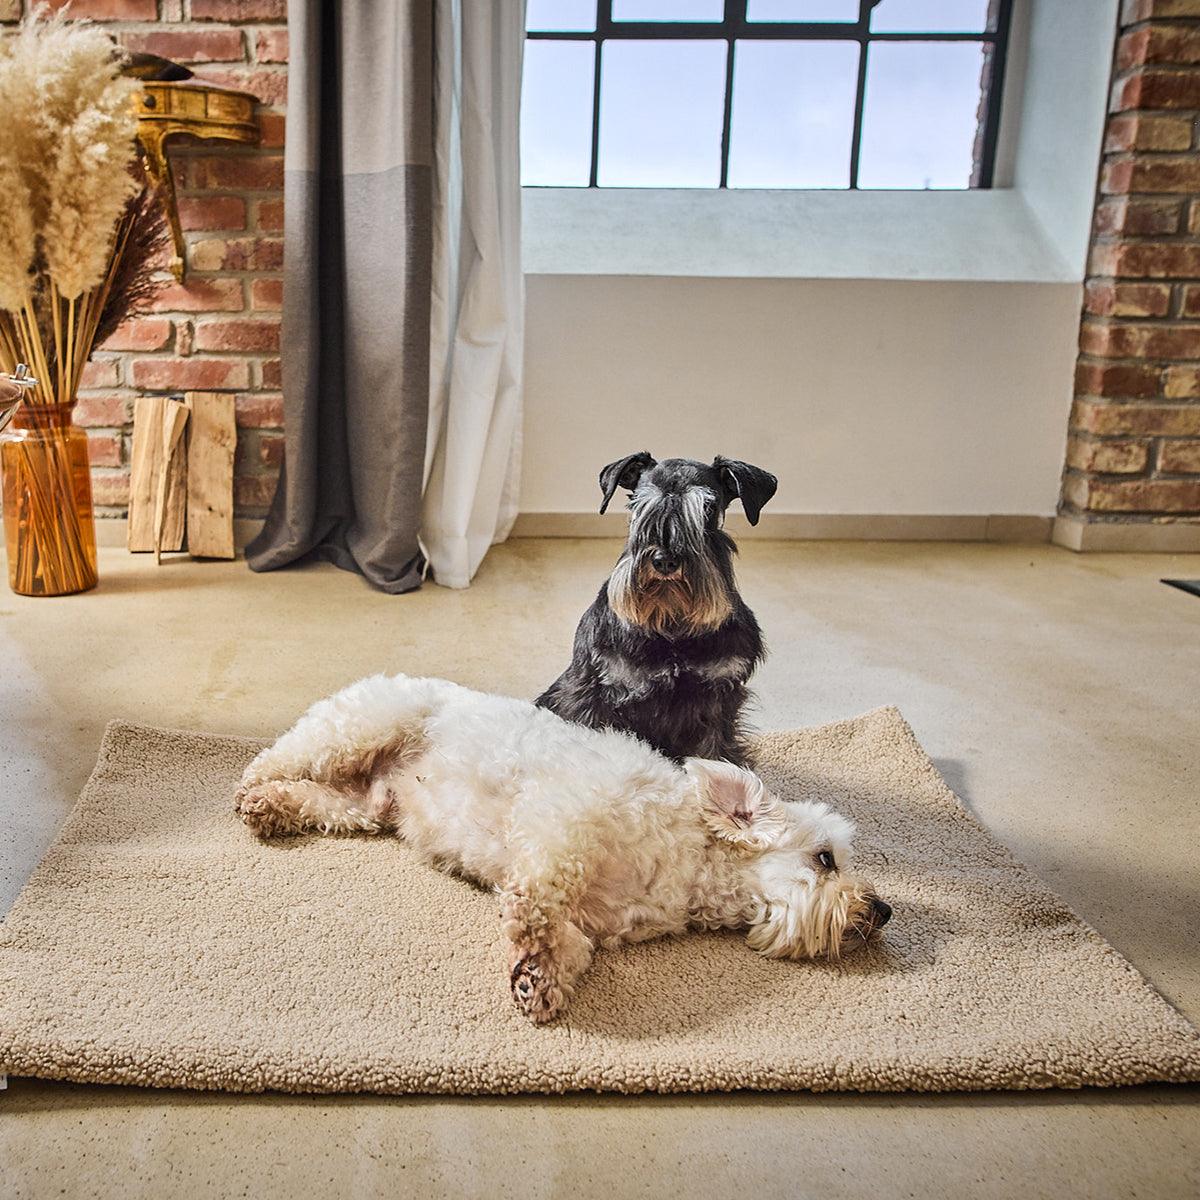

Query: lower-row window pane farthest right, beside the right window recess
[{"left": 858, "top": 42, "right": 983, "bottom": 188}]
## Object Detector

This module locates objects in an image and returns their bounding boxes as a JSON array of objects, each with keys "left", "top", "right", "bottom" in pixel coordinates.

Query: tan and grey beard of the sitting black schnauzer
[{"left": 608, "top": 554, "right": 733, "bottom": 635}]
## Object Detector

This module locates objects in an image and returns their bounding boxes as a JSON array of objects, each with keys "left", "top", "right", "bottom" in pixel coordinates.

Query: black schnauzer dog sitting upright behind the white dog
[{"left": 538, "top": 450, "right": 776, "bottom": 766}]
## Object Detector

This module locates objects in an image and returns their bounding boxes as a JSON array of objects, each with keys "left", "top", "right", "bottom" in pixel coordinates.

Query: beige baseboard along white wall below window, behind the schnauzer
[{"left": 512, "top": 512, "right": 1052, "bottom": 541}]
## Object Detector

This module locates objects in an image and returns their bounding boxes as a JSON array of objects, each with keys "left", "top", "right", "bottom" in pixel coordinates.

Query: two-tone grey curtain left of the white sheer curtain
[{"left": 246, "top": 0, "right": 433, "bottom": 593}]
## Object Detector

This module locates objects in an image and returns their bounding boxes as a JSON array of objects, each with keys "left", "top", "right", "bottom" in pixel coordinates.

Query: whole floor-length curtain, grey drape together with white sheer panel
[{"left": 246, "top": 0, "right": 524, "bottom": 593}]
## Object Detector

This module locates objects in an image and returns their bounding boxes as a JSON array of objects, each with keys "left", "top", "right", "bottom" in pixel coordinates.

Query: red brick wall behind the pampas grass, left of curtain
[{"left": 0, "top": 0, "right": 288, "bottom": 517}]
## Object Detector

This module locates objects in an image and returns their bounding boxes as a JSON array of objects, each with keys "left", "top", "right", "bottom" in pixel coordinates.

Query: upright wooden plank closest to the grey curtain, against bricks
[{"left": 187, "top": 391, "right": 238, "bottom": 558}]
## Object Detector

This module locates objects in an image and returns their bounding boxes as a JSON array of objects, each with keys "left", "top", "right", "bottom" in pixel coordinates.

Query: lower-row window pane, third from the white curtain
[{"left": 730, "top": 41, "right": 858, "bottom": 187}]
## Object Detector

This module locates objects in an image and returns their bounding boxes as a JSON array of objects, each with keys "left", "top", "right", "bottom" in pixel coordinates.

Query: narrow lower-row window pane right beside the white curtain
[{"left": 521, "top": 38, "right": 595, "bottom": 187}]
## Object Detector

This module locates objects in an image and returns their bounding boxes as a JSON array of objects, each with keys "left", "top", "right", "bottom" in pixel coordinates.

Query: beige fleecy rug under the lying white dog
[{"left": 0, "top": 709, "right": 1200, "bottom": 1092}]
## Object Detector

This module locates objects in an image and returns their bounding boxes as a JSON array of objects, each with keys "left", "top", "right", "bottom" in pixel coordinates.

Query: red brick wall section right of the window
[{"left": 1061, "top": 0, "right": 1200, "bottom": 522}]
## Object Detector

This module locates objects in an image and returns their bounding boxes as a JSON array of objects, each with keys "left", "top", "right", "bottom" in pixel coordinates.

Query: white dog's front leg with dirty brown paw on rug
[{"left": 503, "top": 889, "right": 594, "bottom": 1025}]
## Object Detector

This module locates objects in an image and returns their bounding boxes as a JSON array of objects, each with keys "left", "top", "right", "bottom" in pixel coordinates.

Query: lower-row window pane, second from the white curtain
[{"left": 599, "top": 38, "right": 726, "bottom": 187}]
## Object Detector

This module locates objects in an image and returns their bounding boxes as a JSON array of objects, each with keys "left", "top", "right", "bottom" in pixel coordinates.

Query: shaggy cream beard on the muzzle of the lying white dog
[{"left": 746, "top": 878, "right": 880, "bottom": 960}]
